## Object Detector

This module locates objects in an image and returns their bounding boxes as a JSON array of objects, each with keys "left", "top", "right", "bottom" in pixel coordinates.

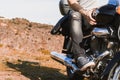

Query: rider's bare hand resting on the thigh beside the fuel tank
[{"left": 80, "top": 9, "right": 96, "bottom": 25}]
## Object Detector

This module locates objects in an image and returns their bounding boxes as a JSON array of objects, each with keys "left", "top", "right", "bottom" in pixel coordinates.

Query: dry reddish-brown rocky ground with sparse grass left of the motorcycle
[{"left": 0, "top": 18, "right": 67, "bottom": 80}]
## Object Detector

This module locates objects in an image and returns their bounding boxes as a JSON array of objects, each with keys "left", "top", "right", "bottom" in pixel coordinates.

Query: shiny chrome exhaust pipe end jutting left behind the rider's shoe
[{"left": 51, "top": 52, "right": 79, "bottom": 71}]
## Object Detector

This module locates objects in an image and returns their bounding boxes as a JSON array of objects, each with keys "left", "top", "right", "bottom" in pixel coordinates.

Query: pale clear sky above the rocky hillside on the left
[{"left": 0, "top": 0, "right": 62, "bottom": 25}]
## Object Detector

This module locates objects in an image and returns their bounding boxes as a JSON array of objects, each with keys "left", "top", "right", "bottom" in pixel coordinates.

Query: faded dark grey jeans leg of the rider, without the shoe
[{"left": 70, "top": 11, "right": 85, "bottom": 59}]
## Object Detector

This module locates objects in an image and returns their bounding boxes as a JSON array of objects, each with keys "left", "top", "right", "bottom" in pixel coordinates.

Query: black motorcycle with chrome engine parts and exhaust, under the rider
[{"left": 51, "top": 5, "right": 120, "bottom": 80}]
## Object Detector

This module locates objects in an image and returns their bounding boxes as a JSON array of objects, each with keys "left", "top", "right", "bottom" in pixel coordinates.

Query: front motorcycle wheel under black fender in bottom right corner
[{"left": 107, "top": 62, "right": 120, "bottom": 80}]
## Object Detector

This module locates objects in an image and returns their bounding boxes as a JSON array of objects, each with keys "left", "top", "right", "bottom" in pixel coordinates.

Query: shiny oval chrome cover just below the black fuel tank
[{"left": 92, "top": 28, "right": 110, "bottom": 36}]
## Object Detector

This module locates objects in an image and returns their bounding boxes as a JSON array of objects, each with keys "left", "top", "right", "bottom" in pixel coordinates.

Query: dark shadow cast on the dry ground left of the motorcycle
[{"left": 7, "top": 60, "right": 67, "bottom": 80}]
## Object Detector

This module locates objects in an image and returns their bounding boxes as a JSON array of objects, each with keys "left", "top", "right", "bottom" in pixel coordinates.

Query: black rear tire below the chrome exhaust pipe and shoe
[{"left": 66, "top": 67, "right": 83, "bottom": 80}]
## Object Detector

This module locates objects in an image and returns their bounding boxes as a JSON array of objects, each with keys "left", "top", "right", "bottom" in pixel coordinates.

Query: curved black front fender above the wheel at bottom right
[{"left": 101, "top": 52, "right": 120, "bottom": 80}]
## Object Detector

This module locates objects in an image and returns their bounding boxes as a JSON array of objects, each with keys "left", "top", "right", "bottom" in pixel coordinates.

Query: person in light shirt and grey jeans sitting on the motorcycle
[{"left": 68, "top": 0, "right": 120, "bottom": 71}]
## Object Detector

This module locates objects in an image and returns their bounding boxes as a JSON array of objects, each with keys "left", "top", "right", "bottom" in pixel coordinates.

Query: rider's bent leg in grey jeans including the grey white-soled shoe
[{"left": 70, "top": 11, "right": 94, "bottom": 70}]
